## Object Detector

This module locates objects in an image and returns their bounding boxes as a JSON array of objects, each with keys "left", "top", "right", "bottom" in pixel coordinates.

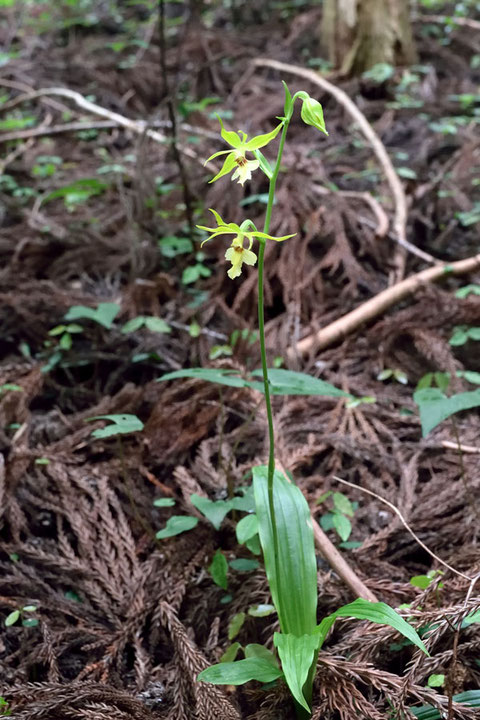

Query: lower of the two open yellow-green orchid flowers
[{"left": 197, "top": 209, "right": 295, "bottom": 280}]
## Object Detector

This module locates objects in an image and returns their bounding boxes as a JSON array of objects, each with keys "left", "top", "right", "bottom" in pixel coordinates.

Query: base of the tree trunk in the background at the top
[{"left": 321, "top": 0, "right": 416, "bottom": 75}]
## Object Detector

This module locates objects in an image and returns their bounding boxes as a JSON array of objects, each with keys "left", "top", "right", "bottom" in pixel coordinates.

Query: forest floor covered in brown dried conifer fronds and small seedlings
[{"left": 0, "top": 3, "right": 480, "bottom": 720}]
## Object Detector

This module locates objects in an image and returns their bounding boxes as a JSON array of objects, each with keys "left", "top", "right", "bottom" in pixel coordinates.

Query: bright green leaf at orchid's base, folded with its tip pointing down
[{"left": 273, "top": 633, "right": 318, "bottom": 711}]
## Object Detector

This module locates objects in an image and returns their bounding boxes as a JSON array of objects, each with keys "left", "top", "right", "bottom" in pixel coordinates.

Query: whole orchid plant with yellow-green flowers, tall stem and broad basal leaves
[{"left": 161, "top": 83, "right": 426, "bottom": 718}]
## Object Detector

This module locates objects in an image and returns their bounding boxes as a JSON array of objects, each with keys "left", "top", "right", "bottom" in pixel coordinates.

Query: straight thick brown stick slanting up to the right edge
[{"left": 287, "top": 255, "right": 480, "bottom": 357}]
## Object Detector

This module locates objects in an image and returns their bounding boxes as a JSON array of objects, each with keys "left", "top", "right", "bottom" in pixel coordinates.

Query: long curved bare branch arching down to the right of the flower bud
[{"left": 253, "top": 58, "right": 407, "bottom": 282}]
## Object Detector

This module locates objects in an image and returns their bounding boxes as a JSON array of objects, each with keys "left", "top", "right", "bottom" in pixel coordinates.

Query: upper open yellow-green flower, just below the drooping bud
[{"left": 206, "top": 118, "right": 283, "bottom": 185}]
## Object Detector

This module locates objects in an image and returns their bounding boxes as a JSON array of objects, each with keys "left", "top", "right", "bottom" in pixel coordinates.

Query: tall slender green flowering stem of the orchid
[{"left": 258, "top": 120, "right": 289, "bottom": 592}]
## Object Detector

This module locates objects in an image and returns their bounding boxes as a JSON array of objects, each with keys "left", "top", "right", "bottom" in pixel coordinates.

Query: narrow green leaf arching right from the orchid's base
[{"left": 318, "top": 598, "right": 428, "bottom": 655}]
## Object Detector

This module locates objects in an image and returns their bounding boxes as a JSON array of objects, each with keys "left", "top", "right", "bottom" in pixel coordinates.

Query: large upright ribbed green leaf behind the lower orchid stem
[{"left": 253, "top": 465, "right": 317, "bottom": 636}]
